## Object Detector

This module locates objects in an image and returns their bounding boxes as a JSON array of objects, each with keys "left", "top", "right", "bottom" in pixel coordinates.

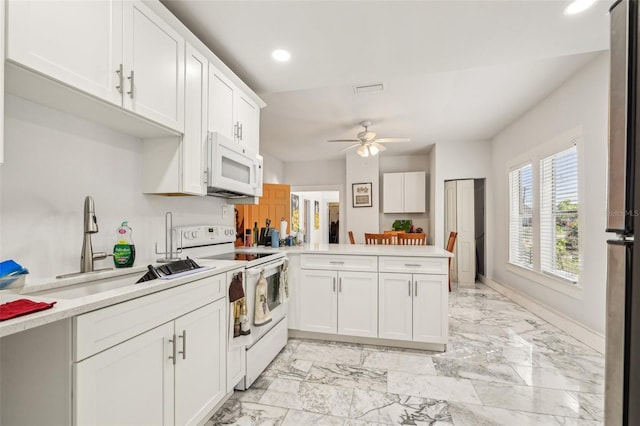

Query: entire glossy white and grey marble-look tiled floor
[{"left": 206, "top": 284, "right": 604, "bottom": 426}]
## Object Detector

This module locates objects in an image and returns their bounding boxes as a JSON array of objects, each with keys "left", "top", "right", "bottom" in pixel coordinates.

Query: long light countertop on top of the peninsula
[{"left": 236, "top": 244, "right": 453, "bottom": 257}]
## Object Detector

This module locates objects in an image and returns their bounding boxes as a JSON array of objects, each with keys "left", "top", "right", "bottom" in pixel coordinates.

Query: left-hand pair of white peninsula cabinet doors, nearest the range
[{"left": 298, "top": 269, "right": 378, "bottom": 337}]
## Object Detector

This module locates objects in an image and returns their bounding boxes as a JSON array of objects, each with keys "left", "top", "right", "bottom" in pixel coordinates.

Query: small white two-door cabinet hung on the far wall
[{"left": 383, "top": 172, "right": 427, "bottom": 213}]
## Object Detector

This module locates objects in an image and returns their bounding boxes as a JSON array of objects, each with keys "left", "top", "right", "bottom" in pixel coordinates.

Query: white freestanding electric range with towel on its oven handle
[{"left": 174, "top": 225, "right": 289, "bottom": 390}]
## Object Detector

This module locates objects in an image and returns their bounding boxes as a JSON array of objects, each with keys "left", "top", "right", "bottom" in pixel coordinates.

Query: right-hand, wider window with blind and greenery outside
[{"left": 540, "top": 146, "right": 580, "bottom": 283}]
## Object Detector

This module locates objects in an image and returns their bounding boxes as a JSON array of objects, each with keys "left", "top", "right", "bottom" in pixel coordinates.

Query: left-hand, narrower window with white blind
[{"left": 509, "top": 164, "right": 533, "bottom": 269}]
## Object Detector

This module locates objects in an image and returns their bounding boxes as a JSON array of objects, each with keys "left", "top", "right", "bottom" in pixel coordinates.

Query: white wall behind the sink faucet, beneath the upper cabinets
[{"left": 0, "top": 96, "right": 233, "bottom": 283}]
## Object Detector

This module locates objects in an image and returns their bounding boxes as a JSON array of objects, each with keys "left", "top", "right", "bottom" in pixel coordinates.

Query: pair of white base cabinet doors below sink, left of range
[{"left": 73, "top": 274, "right": 227, "bottom": 425}]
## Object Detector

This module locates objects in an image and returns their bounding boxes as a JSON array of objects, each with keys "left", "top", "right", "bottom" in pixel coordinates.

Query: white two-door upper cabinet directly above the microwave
[{"left": 208, "top": 64, "right": 260, "bottom": 153}]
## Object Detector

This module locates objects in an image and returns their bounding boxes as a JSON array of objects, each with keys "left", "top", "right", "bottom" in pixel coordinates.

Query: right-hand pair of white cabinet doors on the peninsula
[{"left": 379, "top": 273, "right": 449, "bottom": 343}]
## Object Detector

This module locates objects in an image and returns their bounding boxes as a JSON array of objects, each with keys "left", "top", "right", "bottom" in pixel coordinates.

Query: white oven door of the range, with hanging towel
[{"left": 246, "top": 259, "right": 288, "bottom": 344}]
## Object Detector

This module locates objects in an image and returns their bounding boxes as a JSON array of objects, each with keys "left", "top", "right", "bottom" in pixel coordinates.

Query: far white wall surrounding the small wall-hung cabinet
[{"left": 379, "top": 154, "right": 431, "bottom": 238}]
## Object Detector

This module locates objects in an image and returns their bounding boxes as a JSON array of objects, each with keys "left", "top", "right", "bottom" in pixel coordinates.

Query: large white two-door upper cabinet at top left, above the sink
[{"left": 7, "top": 0, "right": 184, "bottom": 132}]
